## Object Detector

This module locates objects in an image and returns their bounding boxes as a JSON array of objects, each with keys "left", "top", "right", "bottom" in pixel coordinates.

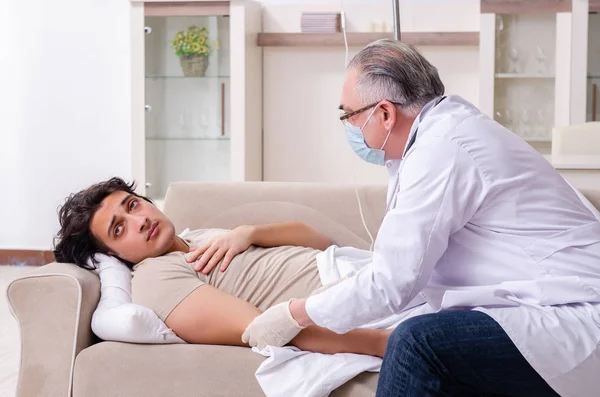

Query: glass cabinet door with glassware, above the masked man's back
[{"left": 494, "top": 14, "right": 557, "bottom": 148}]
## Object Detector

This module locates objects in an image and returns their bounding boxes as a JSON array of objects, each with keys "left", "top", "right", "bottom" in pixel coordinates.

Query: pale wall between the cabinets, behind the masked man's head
[{"left": 262, "top": 0, "right": 480, "bottom": 183}]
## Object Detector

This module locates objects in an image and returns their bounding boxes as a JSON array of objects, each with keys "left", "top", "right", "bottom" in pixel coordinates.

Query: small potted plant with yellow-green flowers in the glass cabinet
[{"left": 171, "top": 26, "right": 216, "bottom": 76}]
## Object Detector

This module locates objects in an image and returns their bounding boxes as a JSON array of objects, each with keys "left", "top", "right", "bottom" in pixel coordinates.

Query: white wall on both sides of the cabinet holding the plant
[{"left": 0, "top": 0, "right": 479, "bottom": 249}]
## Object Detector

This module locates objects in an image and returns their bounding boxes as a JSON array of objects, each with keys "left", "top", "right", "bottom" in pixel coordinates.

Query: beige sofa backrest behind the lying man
[{"left": 164, "top": 182, "right": 386, "bottom": 248}]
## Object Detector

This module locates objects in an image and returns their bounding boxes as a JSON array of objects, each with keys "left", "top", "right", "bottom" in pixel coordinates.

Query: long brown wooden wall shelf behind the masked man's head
[{"left": 256, "top": 32, "right": 479, "bottom": 47}]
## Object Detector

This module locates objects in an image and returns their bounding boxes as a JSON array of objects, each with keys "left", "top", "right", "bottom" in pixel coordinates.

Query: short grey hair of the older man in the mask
[{"left": 348, "top": 39, "right": 444, "bottom": 116}]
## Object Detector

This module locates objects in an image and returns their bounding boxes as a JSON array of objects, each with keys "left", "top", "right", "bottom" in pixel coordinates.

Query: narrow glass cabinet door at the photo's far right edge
[{"left": 586, "top": 12, "right": 600, "bottom": 121}]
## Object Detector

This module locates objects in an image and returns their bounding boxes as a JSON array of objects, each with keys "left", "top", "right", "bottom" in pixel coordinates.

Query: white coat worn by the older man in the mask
[{"left": 306, "top": 96, "right": 600, "bottom": 397}]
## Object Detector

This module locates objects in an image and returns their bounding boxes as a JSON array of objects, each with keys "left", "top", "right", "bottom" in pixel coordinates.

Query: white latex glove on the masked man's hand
[{"left": 242, "top": 301, "right": 306, "bottom": 350}]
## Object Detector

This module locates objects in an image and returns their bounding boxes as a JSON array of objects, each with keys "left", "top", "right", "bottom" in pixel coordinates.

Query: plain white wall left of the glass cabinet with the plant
[{"left": 0, "top": 0, "right": 131, "bottom": 249}]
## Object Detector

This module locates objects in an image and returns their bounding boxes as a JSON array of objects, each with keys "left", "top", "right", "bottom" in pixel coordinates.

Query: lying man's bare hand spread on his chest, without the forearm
[{"left": 186, "top": 226, "right": 254, "bottom": 274}]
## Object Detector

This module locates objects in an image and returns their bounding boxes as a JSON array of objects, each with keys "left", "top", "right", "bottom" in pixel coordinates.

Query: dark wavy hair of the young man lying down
[{"left": 54, "top": 177, "right": 152, "bottom": 270}]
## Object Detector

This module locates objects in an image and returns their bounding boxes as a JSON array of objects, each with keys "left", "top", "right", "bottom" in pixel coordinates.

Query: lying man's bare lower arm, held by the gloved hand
[{"left": 165, "top": 285, "right": 389, "bottom": 357}]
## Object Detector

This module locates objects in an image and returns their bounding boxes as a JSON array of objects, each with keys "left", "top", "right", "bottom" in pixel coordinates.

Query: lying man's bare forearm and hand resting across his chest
[{"left": 186, "top": 222, "right": 331, "bottom": 274}]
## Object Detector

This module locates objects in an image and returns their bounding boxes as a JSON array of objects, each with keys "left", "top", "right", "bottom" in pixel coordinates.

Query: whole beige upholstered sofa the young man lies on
[{"left": 8, "top": 183, "right": 394, "bottom": 397}]
